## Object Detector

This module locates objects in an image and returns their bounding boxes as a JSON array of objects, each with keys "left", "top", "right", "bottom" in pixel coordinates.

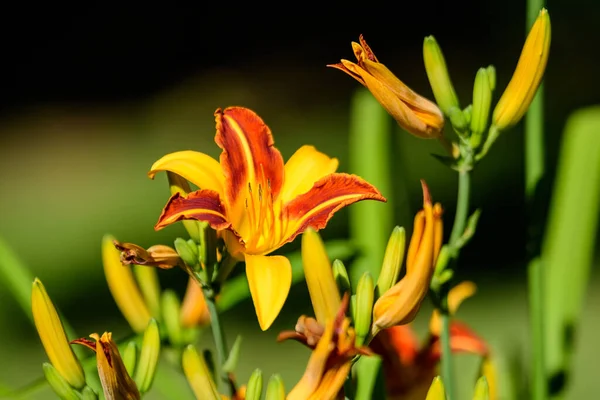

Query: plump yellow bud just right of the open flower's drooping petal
[{"left": 302, "top": 228, "right": 341, "bottom": 325}]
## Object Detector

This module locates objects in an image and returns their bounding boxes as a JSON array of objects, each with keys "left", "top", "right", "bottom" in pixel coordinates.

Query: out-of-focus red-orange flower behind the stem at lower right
[{"left": 369, "top": 282, "right": 495, "bottom": 400}]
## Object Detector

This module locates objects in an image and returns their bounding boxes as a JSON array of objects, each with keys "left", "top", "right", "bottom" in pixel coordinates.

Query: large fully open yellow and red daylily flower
[{"left": 149, "top": 107, "right": 385, "bottom": 330}]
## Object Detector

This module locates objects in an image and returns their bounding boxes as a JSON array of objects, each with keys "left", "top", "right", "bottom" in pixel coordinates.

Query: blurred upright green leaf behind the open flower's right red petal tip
[{"left": 349, "top": 88, "right": 394, "bottom": 284}]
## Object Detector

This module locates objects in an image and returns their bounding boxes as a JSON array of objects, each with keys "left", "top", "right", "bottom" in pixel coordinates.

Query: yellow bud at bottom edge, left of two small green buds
[{"left": 182, "top": 344, "right": 221, "bottom": 400}]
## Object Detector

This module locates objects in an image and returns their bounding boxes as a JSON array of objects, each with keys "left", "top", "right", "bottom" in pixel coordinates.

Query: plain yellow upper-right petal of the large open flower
[{"left": 279, "top": 146, "right": 338, "bottom": 203}]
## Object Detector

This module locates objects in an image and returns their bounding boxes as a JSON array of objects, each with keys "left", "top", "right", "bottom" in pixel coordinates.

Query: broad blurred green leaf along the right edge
[{"left": 542, "top": 107, "right": 600, "bottom": 395}]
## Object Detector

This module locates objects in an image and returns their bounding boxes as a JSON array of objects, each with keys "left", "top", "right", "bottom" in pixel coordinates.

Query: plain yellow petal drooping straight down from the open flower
[{"left": 246, "top": 254, "right": 292, "bottom": 331}]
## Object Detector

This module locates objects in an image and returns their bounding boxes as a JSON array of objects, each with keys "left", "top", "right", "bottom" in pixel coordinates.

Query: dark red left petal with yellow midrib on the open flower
[{"left": 154, "top": 189, "right": 231, "bottom": 230}]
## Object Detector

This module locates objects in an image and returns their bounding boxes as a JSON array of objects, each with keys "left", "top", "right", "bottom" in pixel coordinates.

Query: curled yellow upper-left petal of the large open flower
[{"left": 148, "top": 150, "right": 225, "bottom": 193}]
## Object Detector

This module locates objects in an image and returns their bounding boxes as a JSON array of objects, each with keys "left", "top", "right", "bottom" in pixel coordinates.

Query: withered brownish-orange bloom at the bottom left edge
[{"left": 72, "top": 332, "right": 140, "bottom": 400}]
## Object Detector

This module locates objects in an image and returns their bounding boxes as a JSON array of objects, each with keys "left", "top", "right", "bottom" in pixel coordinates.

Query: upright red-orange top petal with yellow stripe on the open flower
[{"left": 215, "top": 107, "right": 284, "bottom": 231}]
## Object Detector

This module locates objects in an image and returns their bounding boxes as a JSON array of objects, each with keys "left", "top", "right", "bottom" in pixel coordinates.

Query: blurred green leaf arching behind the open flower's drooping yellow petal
[{"left": 217, "top": 240, "right": 356, "bottom": 312}]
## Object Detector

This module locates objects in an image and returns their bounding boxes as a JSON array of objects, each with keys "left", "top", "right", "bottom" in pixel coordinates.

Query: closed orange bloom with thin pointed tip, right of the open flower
[{"left": 372, "top": 181, "right": 443, "bottom": 336}]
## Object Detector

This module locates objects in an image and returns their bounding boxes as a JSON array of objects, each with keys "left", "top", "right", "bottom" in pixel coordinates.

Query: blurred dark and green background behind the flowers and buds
[{"left": 0, "top": 0, "right": 600, "bottom": 399}]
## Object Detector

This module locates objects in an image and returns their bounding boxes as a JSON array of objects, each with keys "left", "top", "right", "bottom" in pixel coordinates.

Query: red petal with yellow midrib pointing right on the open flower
[{"left": 284, "top": 173, "right": 386, "bottom": 241}]
